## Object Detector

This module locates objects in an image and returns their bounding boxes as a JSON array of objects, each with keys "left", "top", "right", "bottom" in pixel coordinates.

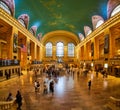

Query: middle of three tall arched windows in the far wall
[{"left": 56, "top": 42, "right": 64, "bottom": 57}]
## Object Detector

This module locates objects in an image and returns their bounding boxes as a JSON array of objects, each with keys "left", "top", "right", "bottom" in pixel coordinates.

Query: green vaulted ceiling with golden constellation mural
[{"left": 14, "top": 0, "right": 108, "bottom": 36}]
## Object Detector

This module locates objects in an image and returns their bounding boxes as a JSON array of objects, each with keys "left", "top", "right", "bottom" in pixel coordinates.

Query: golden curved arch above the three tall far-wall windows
[{"left": 41, "top": 30, "right": 80, "bottom": 46}]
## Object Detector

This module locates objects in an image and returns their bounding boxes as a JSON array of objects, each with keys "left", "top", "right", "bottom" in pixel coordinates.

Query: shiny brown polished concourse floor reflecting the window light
[{"left": 0, "top": 71, "right": 120, "bottom": 110}]
